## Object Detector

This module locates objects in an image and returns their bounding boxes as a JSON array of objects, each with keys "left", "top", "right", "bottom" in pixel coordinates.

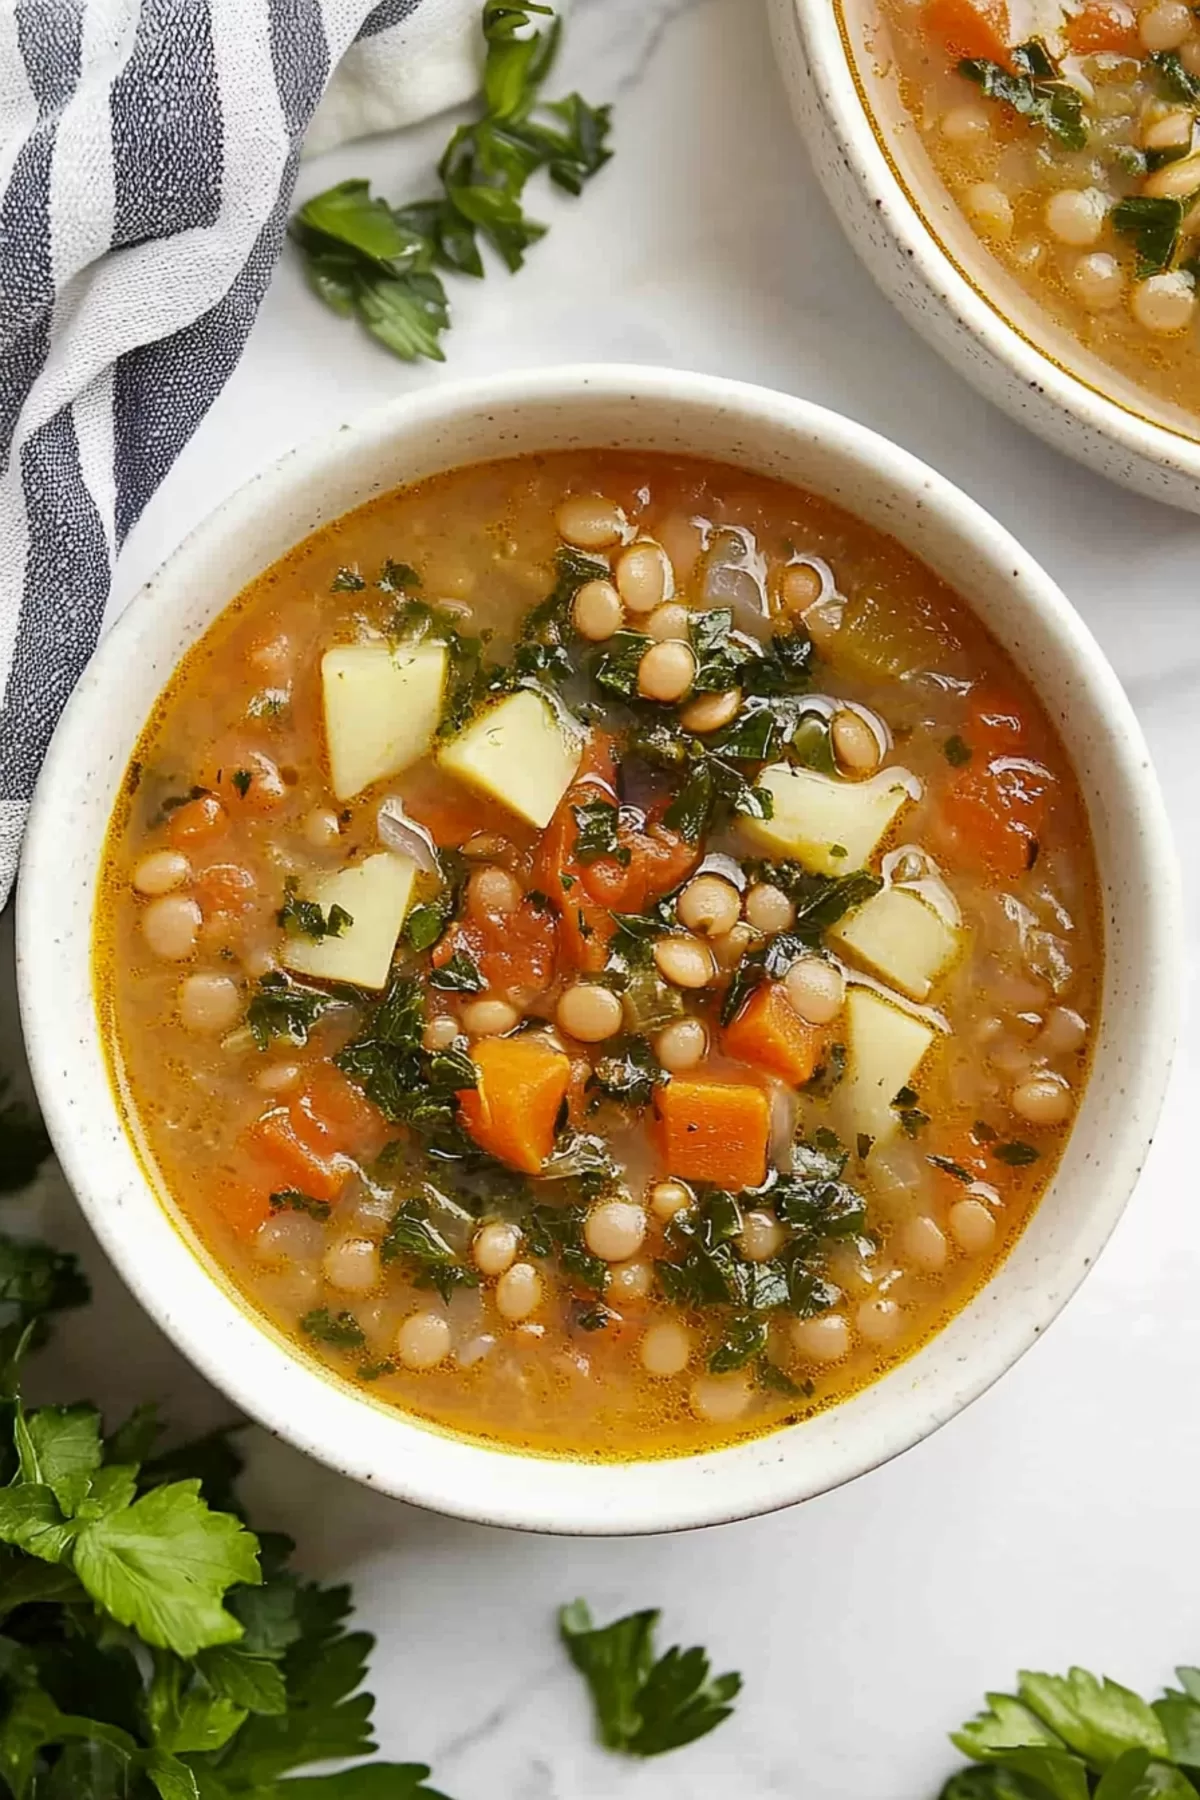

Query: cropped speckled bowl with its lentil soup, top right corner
[{"left": 772, "top": 0, "right": 1200, "bottom": 511}]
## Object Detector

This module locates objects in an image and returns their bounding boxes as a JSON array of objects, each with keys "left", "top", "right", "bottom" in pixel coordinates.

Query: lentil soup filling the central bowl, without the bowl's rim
[{"left": 95, "top": 452, "right": 1101, "bottom": 1458}]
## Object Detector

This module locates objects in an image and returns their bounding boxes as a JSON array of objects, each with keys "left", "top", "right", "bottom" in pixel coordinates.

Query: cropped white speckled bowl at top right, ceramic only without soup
[{"left": 770, "top": 0, "right": 1200, "bottom": 513}]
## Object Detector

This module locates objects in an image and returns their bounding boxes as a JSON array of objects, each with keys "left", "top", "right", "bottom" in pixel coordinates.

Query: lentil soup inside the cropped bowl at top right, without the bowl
[{"left": 873, "top": 0, "right": 1200, "bottom": 434}]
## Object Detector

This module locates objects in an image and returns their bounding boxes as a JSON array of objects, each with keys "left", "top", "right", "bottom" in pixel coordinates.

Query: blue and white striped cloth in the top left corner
[{"left": 0, "top": 0, "right": 479, "bottom": 904}]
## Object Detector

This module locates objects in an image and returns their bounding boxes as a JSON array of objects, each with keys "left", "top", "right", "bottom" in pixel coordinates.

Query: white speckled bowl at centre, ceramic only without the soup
[{"left": 18, "top": 367, "right": 1180, "bottom": 1534}]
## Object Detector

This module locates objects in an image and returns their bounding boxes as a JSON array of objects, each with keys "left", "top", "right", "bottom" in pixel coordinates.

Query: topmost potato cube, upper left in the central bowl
[{"left": 320, "top": 641, "right": 448, "bottom": 799}]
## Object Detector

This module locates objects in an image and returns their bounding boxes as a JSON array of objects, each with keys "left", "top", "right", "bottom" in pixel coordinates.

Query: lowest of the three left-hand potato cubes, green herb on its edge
[{"left": 281, "top": 850, "right": 417, "bottom": 988}]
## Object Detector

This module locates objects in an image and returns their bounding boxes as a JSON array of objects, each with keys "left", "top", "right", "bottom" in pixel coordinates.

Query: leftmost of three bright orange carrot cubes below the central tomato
[{"left": 459, "top": 1037, "right": 570, "bottom": 1175}]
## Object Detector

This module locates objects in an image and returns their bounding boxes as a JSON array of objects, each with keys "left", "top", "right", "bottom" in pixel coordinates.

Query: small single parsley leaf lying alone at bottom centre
[{"left": 558, "top": 1600, "right": 741, "bottom": 1757}]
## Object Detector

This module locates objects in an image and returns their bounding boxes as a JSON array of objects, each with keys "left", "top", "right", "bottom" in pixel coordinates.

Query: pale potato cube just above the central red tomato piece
[{"left": 439, "top": 688, "right": 583, "bottom": 828}]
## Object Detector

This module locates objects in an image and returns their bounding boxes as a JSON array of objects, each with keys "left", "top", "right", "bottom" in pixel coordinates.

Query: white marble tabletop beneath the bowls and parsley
[{"left": 2, "top": 0, "right": 1200, "bottom": 1800}]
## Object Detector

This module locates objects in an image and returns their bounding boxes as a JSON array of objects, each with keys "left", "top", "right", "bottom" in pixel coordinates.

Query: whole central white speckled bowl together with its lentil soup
[{"left": 20, "top": 371, "right": 1173, "bottom": 1530}]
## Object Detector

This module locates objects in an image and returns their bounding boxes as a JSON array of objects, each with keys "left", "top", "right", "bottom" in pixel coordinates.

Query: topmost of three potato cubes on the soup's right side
[{"left": 741, "top": 763, "right": 921, "bottom": 875}]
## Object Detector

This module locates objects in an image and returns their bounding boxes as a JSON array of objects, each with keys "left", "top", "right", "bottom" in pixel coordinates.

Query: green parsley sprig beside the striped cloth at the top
[{"left": 290, "top": 0, "right": 610, "bottom": 362}]
